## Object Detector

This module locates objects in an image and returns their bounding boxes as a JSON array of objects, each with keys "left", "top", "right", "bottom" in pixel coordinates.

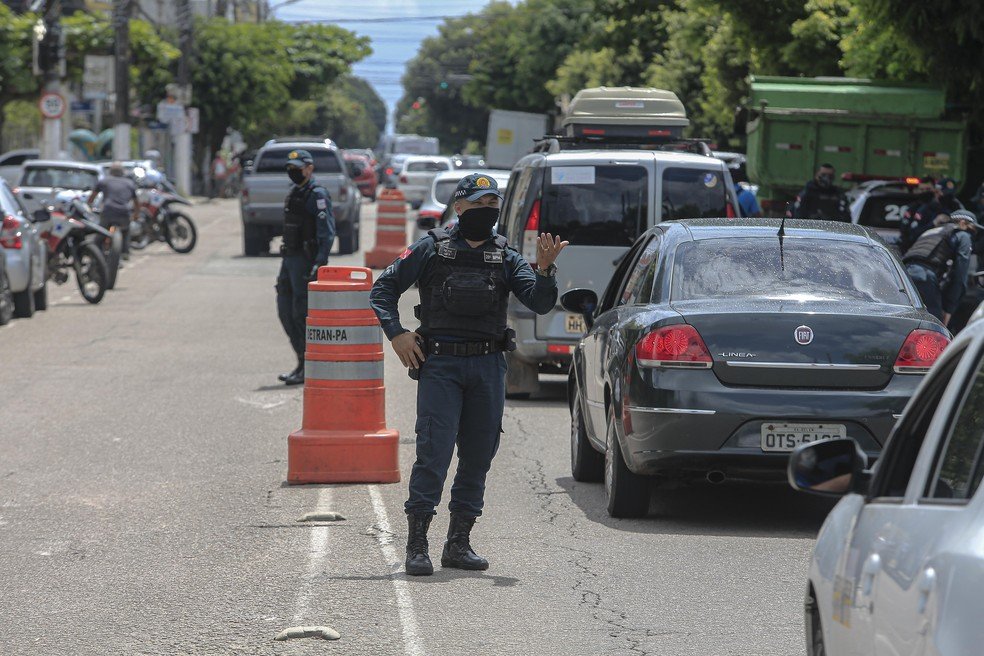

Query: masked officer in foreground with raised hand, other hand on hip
[{"left": 369, "top": 174, "right": 567, "bottom": 575}]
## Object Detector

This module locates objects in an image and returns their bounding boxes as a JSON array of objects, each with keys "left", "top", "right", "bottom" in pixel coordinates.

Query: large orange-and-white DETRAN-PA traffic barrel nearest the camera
[{"left": 287, "top": 267, "right": 400, "bottom": 483}]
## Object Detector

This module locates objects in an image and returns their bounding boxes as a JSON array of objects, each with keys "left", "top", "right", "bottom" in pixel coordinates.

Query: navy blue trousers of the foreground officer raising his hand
[{"left": 405, "top": 353, "right": 506, "bottom": 517}]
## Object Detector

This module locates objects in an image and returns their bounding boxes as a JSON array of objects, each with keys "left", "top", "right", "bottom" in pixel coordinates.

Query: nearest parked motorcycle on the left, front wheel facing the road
[{"left": 34, "top": 201, "right": 110, "bottom": 304}]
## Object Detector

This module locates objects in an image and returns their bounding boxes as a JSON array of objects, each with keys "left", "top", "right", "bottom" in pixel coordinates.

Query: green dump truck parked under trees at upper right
[{"left": 743, "top": 77, "right": 967, "bottom": 214}]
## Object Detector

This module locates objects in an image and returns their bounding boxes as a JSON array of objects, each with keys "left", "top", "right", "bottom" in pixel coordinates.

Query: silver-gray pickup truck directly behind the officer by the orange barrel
[{"left": 239, "top": 139, "right": 362, "bottom": 255}]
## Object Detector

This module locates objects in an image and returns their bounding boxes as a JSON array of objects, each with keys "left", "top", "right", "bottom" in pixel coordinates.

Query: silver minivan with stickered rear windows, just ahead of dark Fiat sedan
[{"left": 499, "top": 146, "right": 738, "bottom": 398}]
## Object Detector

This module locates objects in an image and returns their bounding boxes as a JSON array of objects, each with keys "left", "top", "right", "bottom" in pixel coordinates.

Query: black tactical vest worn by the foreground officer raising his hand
[{"left": 418, "top": 228, "right": 509, "bottom": 340}]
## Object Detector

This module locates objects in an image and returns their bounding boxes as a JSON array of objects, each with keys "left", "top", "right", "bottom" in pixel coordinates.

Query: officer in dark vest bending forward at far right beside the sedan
[{"left": 902, "top": 210, "right": 979, "bottom": 326}]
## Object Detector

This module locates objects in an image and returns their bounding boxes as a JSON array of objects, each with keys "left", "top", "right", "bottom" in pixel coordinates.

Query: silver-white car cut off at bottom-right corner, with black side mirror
[{"left": 788, "top": 322, "right": 984, "bottom": 656}]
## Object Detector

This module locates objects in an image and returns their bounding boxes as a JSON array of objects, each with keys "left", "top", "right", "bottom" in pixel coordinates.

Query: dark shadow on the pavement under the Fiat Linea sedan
[{"left": 557, "top": 477, "right": 836, "bottom": 538}]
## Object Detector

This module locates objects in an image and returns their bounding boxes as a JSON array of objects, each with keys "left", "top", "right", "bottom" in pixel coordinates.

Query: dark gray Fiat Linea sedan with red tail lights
[{"left": 562, "top": 219, "right": 950, "bottom": 517}]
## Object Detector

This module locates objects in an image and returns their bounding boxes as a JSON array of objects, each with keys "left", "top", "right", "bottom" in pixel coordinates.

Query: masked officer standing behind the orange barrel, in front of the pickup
[{"left": 277, "top": 150, "right": 335, "bottom": 385}]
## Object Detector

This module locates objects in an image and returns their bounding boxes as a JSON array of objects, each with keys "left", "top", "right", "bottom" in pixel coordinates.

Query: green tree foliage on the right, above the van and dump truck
[{"left": 397, "top": 0, "right": 984, "bottom": 150}]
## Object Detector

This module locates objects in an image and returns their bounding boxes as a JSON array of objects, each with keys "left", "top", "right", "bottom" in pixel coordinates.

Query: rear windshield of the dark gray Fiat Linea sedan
[{"left": 670, "top": 237, "right": 912, "bottom": 305}]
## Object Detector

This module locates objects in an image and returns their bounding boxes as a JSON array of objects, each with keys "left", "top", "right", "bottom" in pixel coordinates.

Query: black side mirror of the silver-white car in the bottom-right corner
[{"left": 786, "top": 438, "right": 868, "bottom": 497}]
